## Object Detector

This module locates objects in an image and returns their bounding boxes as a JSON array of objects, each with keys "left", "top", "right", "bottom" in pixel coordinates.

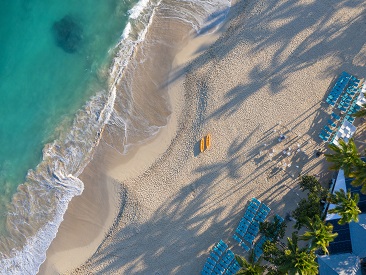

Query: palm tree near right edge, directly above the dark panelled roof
[{"left": 328, "top": 189, "right": 361, "bottom": 224}]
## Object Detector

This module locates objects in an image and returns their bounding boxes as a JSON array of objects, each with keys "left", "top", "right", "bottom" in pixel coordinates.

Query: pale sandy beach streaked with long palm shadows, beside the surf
[{"left": 40, "top": 0, "right": 366, "bottom": 274}]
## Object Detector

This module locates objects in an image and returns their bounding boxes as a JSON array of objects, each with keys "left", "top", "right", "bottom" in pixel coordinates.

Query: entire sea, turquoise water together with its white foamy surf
[{"left": 0, "top": 0, "right": 230, "bottom": 274}]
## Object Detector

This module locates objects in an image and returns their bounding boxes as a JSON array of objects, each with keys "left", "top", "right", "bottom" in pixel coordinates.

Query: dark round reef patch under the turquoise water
[{"left": 52, "top": 15, "right": 83, "bottom": 53}]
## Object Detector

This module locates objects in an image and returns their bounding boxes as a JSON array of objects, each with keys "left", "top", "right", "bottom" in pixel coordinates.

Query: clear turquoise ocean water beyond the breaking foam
[{"left": 0, "top": 0, "right": 136, "bottom": 223}]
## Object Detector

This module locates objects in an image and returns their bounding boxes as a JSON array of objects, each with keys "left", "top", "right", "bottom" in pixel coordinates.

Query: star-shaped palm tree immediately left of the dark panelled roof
[{"left": 300, "top": 215, "right": 338, "bottom": 255}]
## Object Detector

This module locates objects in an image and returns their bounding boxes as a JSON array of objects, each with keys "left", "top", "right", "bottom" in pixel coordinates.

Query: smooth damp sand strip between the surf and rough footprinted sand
[{"left": 39, "top": 1, "right": 226, "bottom": 274}]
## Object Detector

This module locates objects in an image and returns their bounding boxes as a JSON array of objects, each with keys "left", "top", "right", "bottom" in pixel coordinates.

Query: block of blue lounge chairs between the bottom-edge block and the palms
[{"left": 233, "top": 198, "right": 271, "bottom": 251}]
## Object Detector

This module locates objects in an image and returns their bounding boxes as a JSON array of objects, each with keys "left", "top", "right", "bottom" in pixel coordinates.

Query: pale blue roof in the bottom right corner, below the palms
[{"left": 318, "top": 253, "right": 361, "bottom": 275}]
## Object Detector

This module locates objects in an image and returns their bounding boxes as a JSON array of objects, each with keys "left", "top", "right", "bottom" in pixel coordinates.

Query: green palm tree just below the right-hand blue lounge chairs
[{"left": 324, "top": 138, "right": 362, "bottom": 176}]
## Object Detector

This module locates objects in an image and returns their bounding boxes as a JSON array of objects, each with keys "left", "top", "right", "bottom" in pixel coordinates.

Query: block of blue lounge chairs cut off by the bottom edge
[{"left": 201, "top": 240, "right": 240, "bottom": 275}]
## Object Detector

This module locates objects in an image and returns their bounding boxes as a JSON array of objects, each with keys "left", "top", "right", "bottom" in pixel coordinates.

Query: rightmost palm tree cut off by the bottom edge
[{"left": 278, "top": 234, "right": 318, "bottom": 275}]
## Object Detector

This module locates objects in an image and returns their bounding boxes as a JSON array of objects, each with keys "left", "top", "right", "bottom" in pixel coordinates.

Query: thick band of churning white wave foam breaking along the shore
[{"left": 0, "top": 0, "right": 157, "bottom": 274}]
